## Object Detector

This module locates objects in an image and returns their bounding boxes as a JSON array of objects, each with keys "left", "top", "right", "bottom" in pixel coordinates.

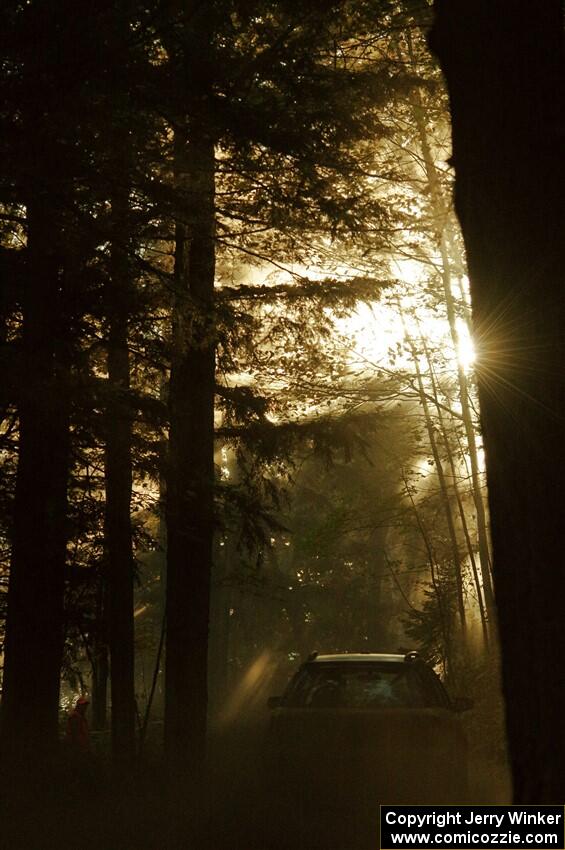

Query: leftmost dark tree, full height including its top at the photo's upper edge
[{"left": 2, "top": 0, "right": 83, "bottom": 754}]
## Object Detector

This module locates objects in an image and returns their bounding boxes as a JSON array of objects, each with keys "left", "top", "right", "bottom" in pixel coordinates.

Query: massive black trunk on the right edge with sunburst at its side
[{"left": 430, "top": 0, "right": 565, "bottom": 803}]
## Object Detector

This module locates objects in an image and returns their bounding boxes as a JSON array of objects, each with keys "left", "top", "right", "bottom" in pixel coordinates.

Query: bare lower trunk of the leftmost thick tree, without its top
[{"left": 2, "top": 196, "right": 69, "bottom": 762}]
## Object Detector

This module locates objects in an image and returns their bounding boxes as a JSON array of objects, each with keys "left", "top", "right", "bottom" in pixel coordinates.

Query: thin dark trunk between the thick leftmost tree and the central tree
[{"left": 105, "top": 193, "right": 135, "bottom": 765}]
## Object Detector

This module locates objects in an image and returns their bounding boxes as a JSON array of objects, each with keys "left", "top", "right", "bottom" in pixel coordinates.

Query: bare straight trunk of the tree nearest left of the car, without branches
[{"left": 165, "top": 117, "right": 215, "bottom": 791}]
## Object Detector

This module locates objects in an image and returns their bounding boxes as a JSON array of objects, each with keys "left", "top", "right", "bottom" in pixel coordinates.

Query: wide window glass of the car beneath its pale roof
[{"left": 284, "top": 663, "right": 443, "bottom": 708}]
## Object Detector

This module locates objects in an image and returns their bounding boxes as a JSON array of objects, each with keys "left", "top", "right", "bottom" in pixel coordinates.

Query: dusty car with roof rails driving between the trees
[{"left": 268, "top": 652, "right": 471, "bottom": 805}]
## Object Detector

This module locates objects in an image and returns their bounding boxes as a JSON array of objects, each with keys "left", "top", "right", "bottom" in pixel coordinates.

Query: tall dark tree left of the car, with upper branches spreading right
[{"left": 156, "top": 2, "right": 398, "bottom": 788}]
